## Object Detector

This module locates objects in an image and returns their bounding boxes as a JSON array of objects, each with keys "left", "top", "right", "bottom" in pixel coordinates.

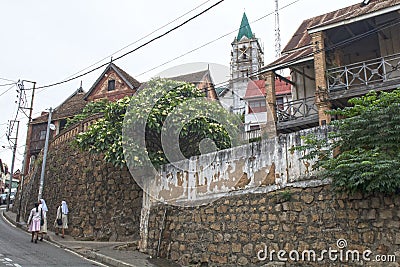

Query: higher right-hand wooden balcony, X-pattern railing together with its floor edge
[{"left": 326, "top": 54, "right": 400, "bottom": 100}]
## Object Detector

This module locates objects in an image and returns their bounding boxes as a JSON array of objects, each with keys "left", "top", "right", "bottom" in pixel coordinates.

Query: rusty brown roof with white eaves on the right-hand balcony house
[{"left": 263, "top": 0, "right": 400, "bottom": 70}]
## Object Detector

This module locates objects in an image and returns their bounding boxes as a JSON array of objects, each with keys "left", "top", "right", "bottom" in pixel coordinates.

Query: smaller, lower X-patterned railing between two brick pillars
[{"left": 276, "top": 97, "right": 318, "bottom": 122}]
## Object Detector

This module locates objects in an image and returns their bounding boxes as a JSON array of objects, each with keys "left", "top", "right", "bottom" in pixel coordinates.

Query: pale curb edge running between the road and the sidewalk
[{"left": 1, "top": 214, "right": 138, "bottom": 267}]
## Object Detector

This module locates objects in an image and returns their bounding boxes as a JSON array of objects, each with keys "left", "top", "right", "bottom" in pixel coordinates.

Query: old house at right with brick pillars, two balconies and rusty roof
[{"left": 261, "top": 0, "right": 400, "bottom": 135}]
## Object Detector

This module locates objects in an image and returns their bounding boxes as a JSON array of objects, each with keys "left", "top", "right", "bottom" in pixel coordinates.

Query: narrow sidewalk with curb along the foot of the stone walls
[{"left": 2, "top": 211, "right": 179, "bottom": 267}]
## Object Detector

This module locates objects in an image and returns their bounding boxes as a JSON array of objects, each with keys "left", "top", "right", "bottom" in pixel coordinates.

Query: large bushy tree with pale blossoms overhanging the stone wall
[{"left": 75, "top": 79, "right": 241, "bottom": 169}]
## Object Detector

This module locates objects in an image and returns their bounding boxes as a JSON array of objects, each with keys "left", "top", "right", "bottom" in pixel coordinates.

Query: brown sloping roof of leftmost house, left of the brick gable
[{"left": 32, "top": 87, "right": 87, "bottom": 124}]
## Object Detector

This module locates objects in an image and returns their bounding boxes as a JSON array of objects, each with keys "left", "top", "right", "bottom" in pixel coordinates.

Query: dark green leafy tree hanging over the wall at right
[{"left": 296, "top": 90, "right": 400, "bottom": 193}]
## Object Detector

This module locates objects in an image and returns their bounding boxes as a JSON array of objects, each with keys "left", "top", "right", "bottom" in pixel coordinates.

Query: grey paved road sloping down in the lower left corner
[{"left": 0, "top": 207, "right": 104, "bottom": 267}]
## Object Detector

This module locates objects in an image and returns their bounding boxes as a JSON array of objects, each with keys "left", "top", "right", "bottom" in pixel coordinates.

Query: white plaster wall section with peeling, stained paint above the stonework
[{"left": 151, "top": 127, "right": 328, "bottom": 204}]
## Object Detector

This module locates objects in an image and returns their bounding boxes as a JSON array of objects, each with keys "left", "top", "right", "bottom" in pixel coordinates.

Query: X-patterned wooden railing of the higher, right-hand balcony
[{"left": 326, "top": 54, "right": 400, "bottom": 92}]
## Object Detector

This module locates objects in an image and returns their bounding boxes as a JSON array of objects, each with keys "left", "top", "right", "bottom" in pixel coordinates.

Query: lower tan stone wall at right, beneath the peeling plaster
[{"left": 148, "top": 183, "right": 400, "bottom": 266}]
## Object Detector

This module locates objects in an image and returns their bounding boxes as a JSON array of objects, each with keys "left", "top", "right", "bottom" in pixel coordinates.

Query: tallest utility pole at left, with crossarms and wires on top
[{"left": 16, "top": 80, "right": 36, "bottom": 222}]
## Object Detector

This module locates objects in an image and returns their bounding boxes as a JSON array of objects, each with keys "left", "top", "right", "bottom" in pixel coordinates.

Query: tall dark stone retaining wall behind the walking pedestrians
[{"left": 15, "top": 141, "right": 143, "bottom": 241}]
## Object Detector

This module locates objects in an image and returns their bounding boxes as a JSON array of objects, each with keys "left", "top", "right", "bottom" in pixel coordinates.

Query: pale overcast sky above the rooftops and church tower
[{"left": 0, "top": 0, "right": 361, "bottom": 170}]
